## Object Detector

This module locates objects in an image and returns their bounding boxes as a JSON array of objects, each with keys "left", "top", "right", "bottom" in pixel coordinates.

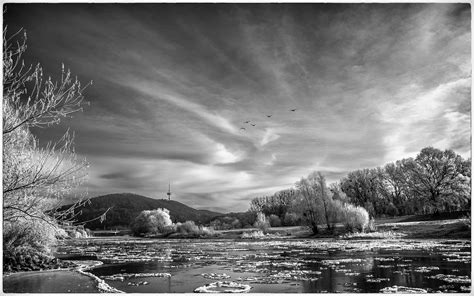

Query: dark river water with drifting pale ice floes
[{"left": 53, "top": 238, "right": 471, "bottom": 293}]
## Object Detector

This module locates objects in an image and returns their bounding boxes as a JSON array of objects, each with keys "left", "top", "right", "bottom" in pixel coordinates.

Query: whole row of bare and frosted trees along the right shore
[{"left": 244, "top": 147, "right": 471, "bottom": 233}]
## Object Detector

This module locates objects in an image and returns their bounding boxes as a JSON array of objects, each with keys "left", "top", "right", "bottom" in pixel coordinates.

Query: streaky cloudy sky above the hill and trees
[{"left": 4, "top": 3, "right": 472, "bottom": 213}]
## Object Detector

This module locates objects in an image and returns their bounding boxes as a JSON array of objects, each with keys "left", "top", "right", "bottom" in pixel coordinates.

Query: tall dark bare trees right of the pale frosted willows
[{"left": 338, "top": 147, "right": 471, "bottom": 217}]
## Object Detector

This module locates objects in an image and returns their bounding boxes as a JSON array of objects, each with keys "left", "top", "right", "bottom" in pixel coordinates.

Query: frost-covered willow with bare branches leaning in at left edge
[{"left": 3, "top": 29, "right": 87, "bottom": 258}]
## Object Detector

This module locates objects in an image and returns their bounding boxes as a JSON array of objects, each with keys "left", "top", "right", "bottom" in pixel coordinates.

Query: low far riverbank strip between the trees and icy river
[{"left": 83, "top": 211, "right": 471, "bottom": 239}]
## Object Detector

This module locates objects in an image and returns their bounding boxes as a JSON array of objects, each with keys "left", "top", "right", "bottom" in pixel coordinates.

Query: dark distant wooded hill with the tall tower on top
[{"left": 63, "top": 193, "right": 222, "bottom": 229}]
